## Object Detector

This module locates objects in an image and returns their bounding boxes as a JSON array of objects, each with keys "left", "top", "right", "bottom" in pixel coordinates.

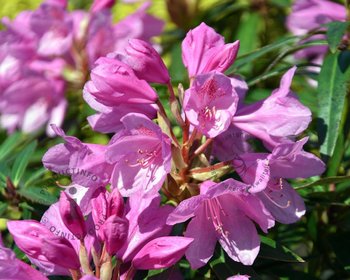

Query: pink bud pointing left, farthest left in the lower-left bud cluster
[{"left": 7, "top": 220, "right": 80, "bottom": 269}]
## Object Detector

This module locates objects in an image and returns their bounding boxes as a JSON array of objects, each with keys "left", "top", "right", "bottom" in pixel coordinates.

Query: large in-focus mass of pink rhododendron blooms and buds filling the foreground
[{"left": 3, "top": 23, "right": 324, "bottom": 279}]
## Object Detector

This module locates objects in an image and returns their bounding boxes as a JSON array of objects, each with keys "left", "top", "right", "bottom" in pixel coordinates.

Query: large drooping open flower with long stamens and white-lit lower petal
[{"left": 167, "top": 179, "right": 274, "bottom": 269}]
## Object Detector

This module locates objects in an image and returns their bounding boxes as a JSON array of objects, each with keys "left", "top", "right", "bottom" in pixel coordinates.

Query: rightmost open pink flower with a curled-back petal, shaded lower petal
[{"left": 232, "top": 138, "right": 325, "bottom": 224}]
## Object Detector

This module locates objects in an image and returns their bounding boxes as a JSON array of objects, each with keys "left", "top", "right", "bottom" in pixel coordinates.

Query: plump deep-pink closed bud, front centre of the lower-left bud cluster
[{"left": 101, "top": 215, "right": 129, "bottom": 255}]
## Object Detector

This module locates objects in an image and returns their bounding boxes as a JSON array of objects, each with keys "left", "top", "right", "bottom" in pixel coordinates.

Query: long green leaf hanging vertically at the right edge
[{"left": 317, "top": 51, "right": 350, "bottom": 157}]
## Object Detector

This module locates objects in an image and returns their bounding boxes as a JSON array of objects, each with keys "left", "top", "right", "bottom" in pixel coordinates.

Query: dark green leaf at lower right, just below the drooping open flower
[{"left": 259, "top": 236, "right": 305, "bottom": 263}]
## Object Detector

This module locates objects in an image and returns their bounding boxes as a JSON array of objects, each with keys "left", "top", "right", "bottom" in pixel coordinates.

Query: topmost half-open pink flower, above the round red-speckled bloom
[{"left": 182, "top": 23, "right": 239, "bottom": 78}]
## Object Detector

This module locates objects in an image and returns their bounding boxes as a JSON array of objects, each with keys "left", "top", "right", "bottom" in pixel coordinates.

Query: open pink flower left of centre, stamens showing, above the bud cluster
[{"left": 106, "top": 113, "right": 171, "bottom": 196}]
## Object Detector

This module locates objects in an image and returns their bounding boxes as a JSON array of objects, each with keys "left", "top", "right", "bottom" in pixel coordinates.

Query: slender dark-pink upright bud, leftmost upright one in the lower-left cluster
[{"left": 59, "top": 192, "right": 86, "bottom": 239}]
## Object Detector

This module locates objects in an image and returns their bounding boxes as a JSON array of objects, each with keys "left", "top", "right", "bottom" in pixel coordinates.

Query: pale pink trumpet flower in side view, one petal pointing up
[{"left": 233, "top": 67, "right": 311, "bottom": 147}]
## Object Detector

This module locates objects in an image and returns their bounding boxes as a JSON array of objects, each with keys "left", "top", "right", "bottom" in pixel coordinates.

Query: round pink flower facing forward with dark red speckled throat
[{"left": 184, "top": 72, "right": 238, "bottom": 138}]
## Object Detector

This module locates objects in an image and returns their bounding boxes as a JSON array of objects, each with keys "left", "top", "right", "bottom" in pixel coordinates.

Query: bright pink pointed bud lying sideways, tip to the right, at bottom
[{"left": 132, "top": 236, "right": 193, "bottom": 270}]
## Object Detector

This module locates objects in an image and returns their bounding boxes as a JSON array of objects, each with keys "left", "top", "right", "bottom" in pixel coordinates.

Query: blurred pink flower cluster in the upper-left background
[{"left": 0, "top": 0, "right": 164, "bottom": 136}]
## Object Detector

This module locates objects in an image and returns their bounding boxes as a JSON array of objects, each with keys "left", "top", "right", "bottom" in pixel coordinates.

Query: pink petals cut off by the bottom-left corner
[{"left": 0, "top": 236, "right": 48, "bottom": 280}]
